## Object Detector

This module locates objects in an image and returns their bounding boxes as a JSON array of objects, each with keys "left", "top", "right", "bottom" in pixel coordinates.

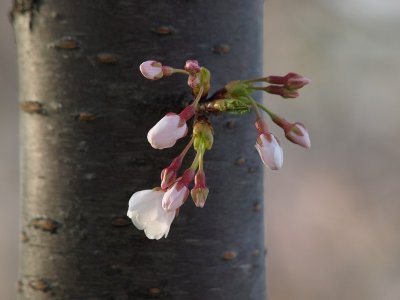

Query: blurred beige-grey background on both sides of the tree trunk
[{"left": 0, "top": 0, "right": 400, "bottom": 300}]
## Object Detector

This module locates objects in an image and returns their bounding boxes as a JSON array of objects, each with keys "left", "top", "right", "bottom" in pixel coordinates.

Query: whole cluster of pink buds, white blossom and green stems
[{"left": 127, "top": 60, "right": 310, "bottom": 239}]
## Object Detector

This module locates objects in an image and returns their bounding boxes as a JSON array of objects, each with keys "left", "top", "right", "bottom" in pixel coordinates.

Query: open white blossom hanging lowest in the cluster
[{"left": 127, "top": 190, "right": 175, "bottom": 240}]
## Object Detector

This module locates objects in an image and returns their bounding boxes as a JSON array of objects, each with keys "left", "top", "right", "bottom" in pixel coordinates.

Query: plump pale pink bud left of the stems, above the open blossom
[{"left": 147, "top": 113, "right": 187, "bottom": 149}]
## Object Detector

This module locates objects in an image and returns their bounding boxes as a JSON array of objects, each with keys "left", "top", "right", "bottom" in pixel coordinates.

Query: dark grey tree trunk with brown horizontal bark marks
[{"left": 11, "top": 0, "right": 265, "bottom": 300}]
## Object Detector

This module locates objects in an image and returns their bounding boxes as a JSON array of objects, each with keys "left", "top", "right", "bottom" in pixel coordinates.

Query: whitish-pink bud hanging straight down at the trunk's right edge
[{"left": 255, "top": 132, "right": 283, "bottom": 170}]
